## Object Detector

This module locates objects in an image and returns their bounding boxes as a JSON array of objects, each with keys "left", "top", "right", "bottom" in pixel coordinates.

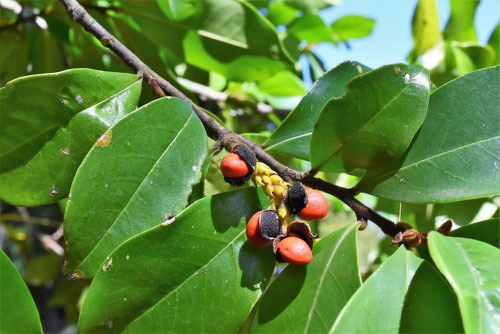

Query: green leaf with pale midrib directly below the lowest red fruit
[{"left": 250, "top": 224, "right": 361, "bottom": 333}]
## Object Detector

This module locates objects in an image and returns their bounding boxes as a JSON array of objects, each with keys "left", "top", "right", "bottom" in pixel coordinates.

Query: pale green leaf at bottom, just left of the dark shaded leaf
[{"left": 330, "top": 247, "right": 423, "bottom": 334}]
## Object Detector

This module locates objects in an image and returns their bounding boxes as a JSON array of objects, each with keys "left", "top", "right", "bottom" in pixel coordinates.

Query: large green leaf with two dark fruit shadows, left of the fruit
[{"left": 79, "top": 187, "right": 274, "bottom": 333}]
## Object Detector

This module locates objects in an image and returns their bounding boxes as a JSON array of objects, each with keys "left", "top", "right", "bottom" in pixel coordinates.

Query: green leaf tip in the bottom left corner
[{"left": 0, "top": 250, "right": 42, "bottom": 333}]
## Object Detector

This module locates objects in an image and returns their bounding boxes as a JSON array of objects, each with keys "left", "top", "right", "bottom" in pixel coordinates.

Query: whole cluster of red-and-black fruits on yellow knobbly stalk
[{"left": 221, "top": 144, "right": 328, "bottom": 265}]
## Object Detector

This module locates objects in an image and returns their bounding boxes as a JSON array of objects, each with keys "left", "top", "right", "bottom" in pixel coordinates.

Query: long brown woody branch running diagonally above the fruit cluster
[{"left": 60, "top": 0, "right": 401, "bottom": 237}]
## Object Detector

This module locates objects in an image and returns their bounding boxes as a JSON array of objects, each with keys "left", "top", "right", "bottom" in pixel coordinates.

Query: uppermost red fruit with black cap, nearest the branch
[{"left": 221, "top": 144, "right": 257, "bottom": 186}]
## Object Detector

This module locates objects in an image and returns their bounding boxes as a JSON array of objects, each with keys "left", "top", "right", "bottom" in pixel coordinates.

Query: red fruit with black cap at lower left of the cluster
[{"left": 247, "top": 210, "right": 281, "bottom": 247}]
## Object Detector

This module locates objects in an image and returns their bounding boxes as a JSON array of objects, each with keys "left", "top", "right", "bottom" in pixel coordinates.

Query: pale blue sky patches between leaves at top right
[{"left": 308, "top": 0, "right": 500, "bottom": 75}]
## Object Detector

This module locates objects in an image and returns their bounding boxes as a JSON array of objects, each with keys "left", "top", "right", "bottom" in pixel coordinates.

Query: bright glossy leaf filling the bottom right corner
[{"left": 429, "top": 232, "right": 500, "bottom": 333}]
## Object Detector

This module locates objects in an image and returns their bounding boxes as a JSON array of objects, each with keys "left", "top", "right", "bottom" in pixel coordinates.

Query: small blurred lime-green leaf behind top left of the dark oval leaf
[{"left": 258, "top": 71, "right": 307, "bottom": 96}]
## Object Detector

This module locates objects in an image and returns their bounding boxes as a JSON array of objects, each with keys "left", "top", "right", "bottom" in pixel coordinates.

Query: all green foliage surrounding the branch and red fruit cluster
[{"left": 0, "top": 0, "right": 500, "bottom": 333}]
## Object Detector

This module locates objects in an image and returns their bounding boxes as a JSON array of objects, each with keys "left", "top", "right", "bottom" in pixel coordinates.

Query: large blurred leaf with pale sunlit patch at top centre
[{"left": 117, "top": 0, "right": 290, "bottom": 81}]
